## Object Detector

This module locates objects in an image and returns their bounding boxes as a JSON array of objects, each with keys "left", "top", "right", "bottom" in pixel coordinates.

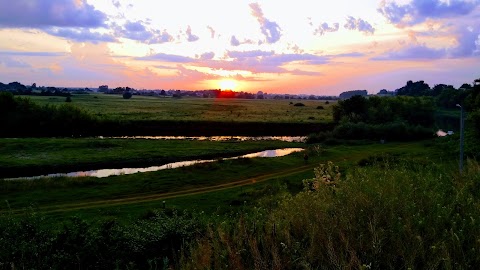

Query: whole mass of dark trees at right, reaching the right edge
[{"left": 309, "top": 77, "right": 480, "bottom": 142}]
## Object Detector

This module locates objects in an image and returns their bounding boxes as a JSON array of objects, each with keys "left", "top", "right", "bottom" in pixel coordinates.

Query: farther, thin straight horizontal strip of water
[{"left": 107, "top": 136, "right": 307, "bottom": 142}]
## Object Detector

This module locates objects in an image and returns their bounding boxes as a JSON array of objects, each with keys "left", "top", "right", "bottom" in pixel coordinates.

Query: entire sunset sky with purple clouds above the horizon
[{"left": 0, "top": 0, "right": 480, "bottom": 95}]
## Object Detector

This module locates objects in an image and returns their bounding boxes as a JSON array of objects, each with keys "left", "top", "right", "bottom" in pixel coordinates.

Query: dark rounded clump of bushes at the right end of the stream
[{"left": 310, "top": 96, "right": 435, "bottom": 142}]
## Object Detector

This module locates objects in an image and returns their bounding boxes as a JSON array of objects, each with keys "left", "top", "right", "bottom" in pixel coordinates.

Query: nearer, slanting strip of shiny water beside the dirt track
[{"left": 6, "top": 148, "right": 304, "bottom": 180}]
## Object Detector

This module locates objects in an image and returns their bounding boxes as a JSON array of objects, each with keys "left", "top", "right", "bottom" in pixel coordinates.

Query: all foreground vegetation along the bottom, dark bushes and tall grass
[{"left": 0, "top": 151, "right": 480, "bottom": 269}]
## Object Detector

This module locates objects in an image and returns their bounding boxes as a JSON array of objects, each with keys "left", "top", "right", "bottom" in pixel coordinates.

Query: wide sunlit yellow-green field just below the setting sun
[{"left": 29, "top": 94, "right": 335, "bottom": 123}]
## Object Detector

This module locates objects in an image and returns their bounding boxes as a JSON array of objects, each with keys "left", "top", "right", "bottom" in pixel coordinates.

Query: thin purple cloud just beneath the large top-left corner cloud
[{"left": 45, "top": 28, "right": 116, "bottom": 43}]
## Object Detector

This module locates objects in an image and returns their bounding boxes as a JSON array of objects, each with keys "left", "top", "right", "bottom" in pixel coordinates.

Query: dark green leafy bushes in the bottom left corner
[{"left": 0, "top": 211, "right": 204, "bottom": 269}]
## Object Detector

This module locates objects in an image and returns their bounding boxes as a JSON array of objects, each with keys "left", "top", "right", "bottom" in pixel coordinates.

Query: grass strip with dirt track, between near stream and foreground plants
[{"left": 0, "top": 142, "right": 432, "bottom": 223}]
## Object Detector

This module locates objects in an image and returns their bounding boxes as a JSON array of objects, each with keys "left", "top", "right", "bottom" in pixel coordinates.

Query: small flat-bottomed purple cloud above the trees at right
[{"left": 372, "top": 45, "right": 447, "bottom": 61}]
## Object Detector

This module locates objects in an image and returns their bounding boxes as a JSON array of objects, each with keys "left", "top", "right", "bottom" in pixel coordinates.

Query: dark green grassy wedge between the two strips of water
[{"left": 0, "top": 138, "right": 303, "bottom": 177}]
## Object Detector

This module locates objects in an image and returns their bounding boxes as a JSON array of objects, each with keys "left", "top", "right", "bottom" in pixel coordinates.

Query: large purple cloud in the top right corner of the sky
[{"left": 378, "top": 0, "right": 480, "bottom": 26}]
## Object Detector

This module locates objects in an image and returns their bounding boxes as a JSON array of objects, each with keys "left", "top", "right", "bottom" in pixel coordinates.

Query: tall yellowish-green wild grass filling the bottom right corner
[{"left": 182, "top": 160, "right": 480, "bottom": 269}]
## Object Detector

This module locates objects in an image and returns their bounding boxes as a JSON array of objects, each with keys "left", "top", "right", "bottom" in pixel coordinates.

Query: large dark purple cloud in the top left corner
[{"left": 0, "top": 0, "right": 107, "bottom": 28}]
